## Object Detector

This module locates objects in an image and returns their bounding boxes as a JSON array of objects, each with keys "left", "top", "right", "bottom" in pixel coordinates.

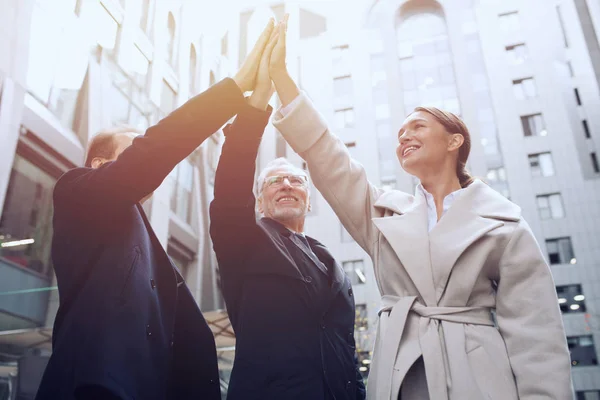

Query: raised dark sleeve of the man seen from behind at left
[{"left": 55, "top": 78, "right": 246, "bottom": 209}]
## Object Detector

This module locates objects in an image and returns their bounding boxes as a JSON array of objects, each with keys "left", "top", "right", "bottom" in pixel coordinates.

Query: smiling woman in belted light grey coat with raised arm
[{"left": 271, "top": 17, "right": 573, "bottom": 400}]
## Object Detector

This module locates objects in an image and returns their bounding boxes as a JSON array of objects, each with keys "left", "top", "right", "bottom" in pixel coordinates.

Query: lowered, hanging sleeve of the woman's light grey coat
[{"left": 496, "top": 220, "right": 573, "bottom": 400}]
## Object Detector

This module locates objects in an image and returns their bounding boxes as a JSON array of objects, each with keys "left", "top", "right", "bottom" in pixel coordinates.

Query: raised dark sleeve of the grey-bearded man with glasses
[{"left": 210, "top": 106, "right": 272, "bottom": 269}]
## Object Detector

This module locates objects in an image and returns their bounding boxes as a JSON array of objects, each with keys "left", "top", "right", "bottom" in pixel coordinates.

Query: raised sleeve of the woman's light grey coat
[{"left": 273, "top": 94, "right": 383, "bottom": 254}]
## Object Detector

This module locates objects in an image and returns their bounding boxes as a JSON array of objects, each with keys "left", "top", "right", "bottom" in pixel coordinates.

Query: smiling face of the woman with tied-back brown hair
[{"left": 396, "top": 111, "right": 464, "bottom": 180}]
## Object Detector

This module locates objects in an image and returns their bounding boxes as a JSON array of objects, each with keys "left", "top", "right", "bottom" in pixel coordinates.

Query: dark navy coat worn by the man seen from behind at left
[{"left": 36, "top": 79, "right": 249, "bottom": 400}]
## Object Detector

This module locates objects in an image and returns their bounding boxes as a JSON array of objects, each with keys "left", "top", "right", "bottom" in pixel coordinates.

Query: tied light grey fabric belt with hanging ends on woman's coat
[{"left": 369, "top": 295, "right": 494, "bottom": 400}]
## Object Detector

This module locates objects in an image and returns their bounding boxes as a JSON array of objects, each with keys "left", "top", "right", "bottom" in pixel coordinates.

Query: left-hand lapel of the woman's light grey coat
[{"left": 373, "top": 193, "right": 435, "bottom": 305}]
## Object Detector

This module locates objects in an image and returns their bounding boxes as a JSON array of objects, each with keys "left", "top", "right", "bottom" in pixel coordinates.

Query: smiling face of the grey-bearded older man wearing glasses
[{"left": 257, "top": 166, "right": 310, "bottom": 225}]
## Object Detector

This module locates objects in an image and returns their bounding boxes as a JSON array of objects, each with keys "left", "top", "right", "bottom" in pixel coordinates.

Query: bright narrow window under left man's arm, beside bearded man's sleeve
[{"left": 169, "top": 159, "right": 194, "bottom": 225}]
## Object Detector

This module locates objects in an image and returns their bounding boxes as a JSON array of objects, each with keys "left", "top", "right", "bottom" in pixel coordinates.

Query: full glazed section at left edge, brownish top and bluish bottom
[{"left": 0, "top": 154, "right": 56, "bottom": 331}]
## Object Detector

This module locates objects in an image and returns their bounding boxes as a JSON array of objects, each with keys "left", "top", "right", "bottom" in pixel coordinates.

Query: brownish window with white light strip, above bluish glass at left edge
[{"left": 0, "top": 154, "right": 56, "bottom": 276}]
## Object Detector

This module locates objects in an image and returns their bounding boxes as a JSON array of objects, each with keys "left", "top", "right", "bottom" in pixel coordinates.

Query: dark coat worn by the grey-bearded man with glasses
[{"left": 210, "top": 106, "right": 365, "bottom": 400}]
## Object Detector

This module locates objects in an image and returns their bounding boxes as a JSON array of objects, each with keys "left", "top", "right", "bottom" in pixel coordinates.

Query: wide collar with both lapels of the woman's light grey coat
[{"left": 373, "top": 180, "right": 521, "bottom": 305}]
